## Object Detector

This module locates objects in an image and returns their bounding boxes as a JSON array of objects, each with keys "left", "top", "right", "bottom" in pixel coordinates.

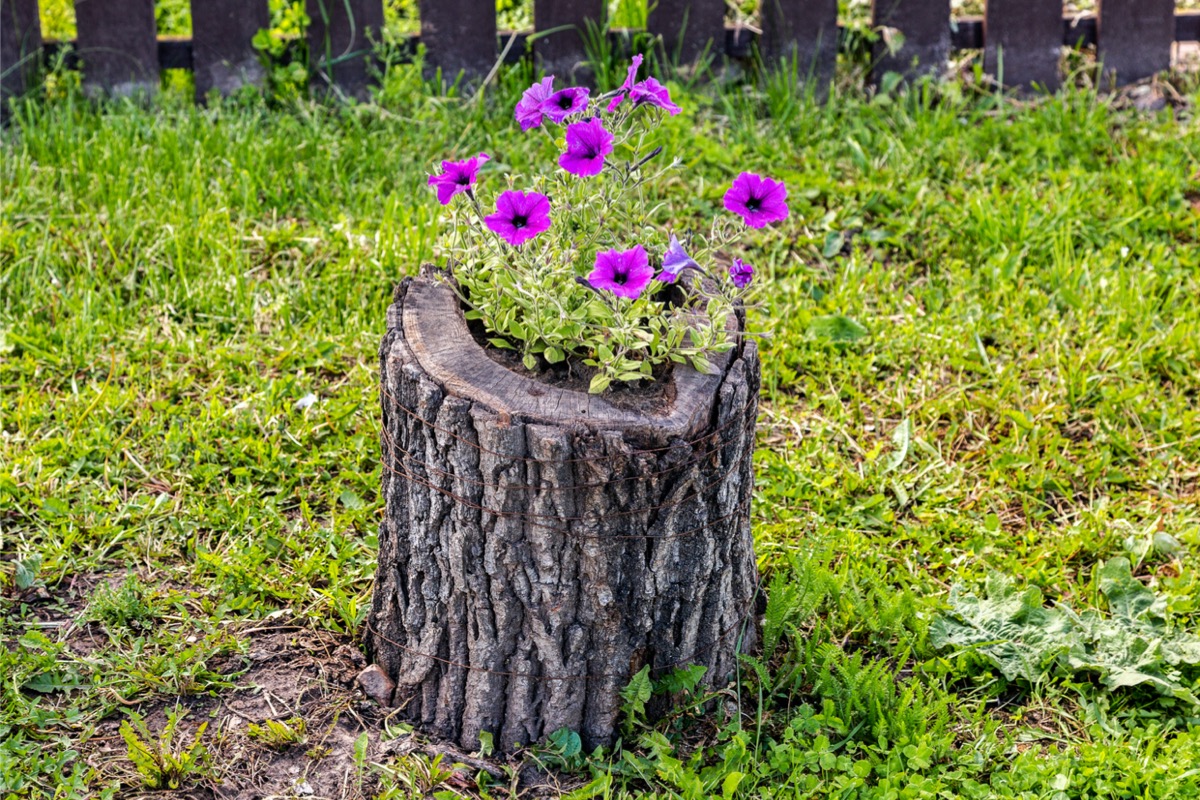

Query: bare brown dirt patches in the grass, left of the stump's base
[{"left": 14, "top": 572, "right": 584, "bottom": 800}]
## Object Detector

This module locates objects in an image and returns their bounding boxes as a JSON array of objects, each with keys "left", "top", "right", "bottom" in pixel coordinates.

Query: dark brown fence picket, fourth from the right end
[{"left": 761, "top": 0, "right": 838, "bottom": 92}]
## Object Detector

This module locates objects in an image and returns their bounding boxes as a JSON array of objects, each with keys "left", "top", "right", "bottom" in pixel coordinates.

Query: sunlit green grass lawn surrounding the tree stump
[{"left": 7, "top": 57, "right": 1200, "bottom": 799}]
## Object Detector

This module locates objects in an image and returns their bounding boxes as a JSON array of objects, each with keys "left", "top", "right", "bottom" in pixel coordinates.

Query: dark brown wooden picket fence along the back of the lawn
[{"left": 0, "top": 0, "right": 1200, "bottom": 100}]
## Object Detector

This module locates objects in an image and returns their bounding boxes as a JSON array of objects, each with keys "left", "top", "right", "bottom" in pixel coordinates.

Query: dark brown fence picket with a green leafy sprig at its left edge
[{"left": 871, "top": 0, "right": 950, "bottom": 83}]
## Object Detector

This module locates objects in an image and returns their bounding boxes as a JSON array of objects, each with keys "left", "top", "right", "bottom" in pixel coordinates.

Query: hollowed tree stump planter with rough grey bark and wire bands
[{"left": 366, "top": 279, "right": 760, "bottom": 750}]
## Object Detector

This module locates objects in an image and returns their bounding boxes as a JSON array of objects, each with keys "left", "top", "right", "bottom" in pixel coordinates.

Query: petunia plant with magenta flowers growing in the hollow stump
[{"left": 428, "top": 55, "right": 787, "bottom": 392}]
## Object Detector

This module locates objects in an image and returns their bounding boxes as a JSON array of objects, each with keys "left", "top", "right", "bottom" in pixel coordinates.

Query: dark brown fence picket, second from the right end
[{"left": 983, "top": 0, "right": 1063, "bottom": 91}]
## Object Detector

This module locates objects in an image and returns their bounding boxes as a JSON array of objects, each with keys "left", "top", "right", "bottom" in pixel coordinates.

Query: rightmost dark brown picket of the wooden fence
[{"left": 1096, "top": 0, "right": 1175, "bottom": 85}]
